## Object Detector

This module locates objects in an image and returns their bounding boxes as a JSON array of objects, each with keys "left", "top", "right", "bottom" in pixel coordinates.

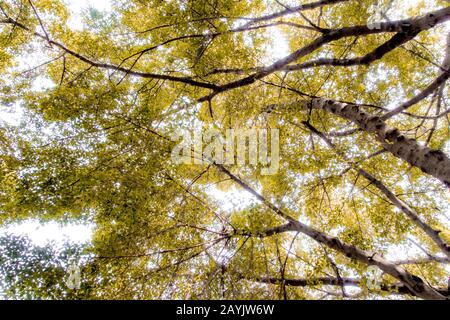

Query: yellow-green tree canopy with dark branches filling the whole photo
[{"left": 0, "top": 0, "right": 450, "bottom": 299}]
